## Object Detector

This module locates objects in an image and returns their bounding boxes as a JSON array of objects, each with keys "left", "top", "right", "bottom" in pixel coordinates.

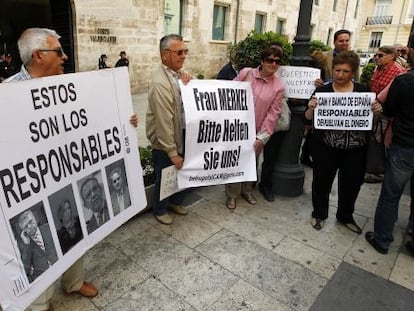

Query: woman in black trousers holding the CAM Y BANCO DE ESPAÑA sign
[{"left": 305, "top": 51, "right": 369, "bottom": 234}]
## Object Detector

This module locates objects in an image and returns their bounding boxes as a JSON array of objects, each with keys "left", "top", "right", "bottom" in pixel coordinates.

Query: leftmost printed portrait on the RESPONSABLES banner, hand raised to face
[{"left": 10, "top": 206, "right": 58, "bottom": 283}]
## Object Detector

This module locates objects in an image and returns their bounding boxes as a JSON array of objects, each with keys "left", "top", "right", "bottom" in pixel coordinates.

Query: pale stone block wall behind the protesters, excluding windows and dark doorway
[{"left": 72, "top": 0, "right": 360, "bottom": 93}]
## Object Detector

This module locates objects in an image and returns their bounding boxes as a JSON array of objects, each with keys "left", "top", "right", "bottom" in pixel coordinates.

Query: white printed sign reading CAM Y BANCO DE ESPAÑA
[{"left": 313, "top": 92, "right": 375, "bottom": 131}]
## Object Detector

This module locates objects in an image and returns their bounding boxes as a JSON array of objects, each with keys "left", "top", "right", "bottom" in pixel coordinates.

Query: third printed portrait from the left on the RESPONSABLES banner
[{"left": 78, "top": 172, "right": 109, "bottom": 233}]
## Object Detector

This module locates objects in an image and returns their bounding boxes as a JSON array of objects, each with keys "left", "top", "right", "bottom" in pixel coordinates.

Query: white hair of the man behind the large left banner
[{"left": 17, "top": 28, "right": 60, "bottom": 65}]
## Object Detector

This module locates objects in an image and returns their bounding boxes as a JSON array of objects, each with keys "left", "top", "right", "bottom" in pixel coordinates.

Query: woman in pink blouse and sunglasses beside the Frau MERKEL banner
[{"left": 226, "top": 47, "right": 285, "bottom": 209}]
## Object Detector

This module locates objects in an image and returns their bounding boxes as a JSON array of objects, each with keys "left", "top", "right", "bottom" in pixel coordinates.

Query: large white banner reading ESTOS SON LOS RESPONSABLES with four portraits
[{"left": 0, "top": 67, "right": 146, "bottom": 310}]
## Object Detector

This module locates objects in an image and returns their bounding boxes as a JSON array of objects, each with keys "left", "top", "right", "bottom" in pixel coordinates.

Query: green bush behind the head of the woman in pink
[{"left": 234, "top": 30, "right": 292, "bottom": 69}]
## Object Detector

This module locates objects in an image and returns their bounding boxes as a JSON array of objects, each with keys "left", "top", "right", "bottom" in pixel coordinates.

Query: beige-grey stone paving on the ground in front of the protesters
[{"left": 48, "top": 94, "right": 414, "bottom": 311}]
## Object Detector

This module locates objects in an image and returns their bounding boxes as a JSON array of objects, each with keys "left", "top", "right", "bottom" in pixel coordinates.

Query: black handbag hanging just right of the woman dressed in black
[{"left": 365, "top": 120, "right": 385, "bottom": 174}]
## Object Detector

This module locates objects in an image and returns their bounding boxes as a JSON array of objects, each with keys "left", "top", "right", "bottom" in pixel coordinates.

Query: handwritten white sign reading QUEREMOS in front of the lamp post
[{"left": 277, "top": 66, "right": 321, "bottom": 99}]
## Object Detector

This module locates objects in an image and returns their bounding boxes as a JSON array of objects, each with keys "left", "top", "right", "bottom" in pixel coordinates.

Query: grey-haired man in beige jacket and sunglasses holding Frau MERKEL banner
[{"left": 146, "top": 34, "right": 190, "bottom": 225}]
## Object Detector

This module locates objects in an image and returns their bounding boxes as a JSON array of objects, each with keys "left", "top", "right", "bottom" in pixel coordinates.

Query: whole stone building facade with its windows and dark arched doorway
[{"left": 0, "top": 0, "right": 366, "bottom": 93}]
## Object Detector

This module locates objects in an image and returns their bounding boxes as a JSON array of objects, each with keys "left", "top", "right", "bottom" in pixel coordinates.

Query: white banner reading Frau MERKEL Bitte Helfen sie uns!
[{"left": 178, "top": 80, "right": 257, "bottom": 188}]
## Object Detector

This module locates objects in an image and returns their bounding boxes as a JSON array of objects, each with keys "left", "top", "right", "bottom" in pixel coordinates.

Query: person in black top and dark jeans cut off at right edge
[{"left": 365, "top": 33, "right": 414, "bottom": 256}]
